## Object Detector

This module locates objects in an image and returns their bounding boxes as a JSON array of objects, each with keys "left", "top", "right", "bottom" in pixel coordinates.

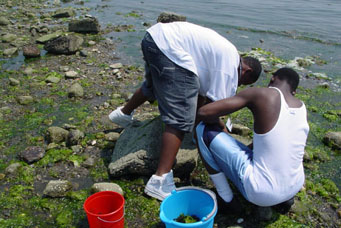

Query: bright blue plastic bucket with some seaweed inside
[{"left": 160, "top": 187, "right": 217, "bottom": 228}]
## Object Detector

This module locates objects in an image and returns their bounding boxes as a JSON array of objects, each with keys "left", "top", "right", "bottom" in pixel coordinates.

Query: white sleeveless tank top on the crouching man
[{"left": 243, "top": 87, "right": 309, "bottom": 206}]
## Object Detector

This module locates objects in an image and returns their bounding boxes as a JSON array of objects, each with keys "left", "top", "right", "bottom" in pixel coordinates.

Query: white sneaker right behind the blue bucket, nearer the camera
[{"left": 144, "top": 170, "right": 175, "bottom": 201}]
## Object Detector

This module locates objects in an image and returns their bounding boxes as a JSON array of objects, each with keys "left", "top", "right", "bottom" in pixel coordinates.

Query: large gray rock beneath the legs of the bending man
[{"left": 109, "top": 117, "right": 198, "bottom": 177}]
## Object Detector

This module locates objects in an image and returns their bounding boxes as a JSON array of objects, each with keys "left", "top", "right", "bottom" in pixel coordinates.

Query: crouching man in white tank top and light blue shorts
[{"left": 196, "top": 68, "right": 309, "bottom": 212}]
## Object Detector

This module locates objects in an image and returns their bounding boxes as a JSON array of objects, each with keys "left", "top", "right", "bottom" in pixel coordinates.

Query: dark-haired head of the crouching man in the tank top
[{"left": 269, "top": 67, "right": 300, "bottom": 94}]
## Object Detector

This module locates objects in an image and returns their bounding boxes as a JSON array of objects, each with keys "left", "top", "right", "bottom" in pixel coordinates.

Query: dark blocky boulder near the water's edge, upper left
[{"left": 69, "top": 18, "right": 101, "bottom": 33}]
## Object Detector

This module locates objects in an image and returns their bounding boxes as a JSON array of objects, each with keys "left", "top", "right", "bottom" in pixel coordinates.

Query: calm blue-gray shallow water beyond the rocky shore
[{"left": 70, "top": 0, "right": 341, "bottom": 85}]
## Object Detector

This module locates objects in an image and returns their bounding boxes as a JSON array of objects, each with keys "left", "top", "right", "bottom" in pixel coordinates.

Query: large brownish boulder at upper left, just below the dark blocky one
[{"left": 44, "top": 35, "right": 84, "bottom": 55}]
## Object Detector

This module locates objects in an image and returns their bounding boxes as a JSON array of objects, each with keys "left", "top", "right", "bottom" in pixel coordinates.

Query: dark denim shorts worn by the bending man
[{"left": 141, "top": 32, "right": 200, "bottom": 132}]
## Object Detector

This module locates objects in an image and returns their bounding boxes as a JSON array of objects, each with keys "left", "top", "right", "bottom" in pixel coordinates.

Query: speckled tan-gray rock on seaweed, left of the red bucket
[{"left": 43, "top": 180, "right": 72, "bottom": 198}]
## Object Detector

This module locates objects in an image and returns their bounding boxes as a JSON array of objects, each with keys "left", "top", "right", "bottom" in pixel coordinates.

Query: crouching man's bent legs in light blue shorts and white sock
[{"left": 196, "top": 123, "right": 252, "bottom": 212}]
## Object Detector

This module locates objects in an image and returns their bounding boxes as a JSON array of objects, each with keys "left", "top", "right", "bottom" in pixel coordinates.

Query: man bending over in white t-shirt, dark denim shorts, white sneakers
[{"left": 109, "top": 22, "right": 261, "bottom": 200}]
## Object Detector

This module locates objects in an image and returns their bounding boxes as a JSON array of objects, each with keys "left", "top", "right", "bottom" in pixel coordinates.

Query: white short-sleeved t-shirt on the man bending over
[{"left": 147, "top": 22, "right": 240, "bottom": 101}]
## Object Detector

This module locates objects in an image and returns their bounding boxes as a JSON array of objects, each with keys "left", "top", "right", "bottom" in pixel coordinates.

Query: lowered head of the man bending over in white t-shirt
[{"left": 238, "top": 56, "right": 262, "bottom": 86}]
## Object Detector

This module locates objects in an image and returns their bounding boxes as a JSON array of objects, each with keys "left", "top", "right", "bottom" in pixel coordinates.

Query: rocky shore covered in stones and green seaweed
[{"left": 0, "top": 0, "right": 341, "bottom": 227}]
